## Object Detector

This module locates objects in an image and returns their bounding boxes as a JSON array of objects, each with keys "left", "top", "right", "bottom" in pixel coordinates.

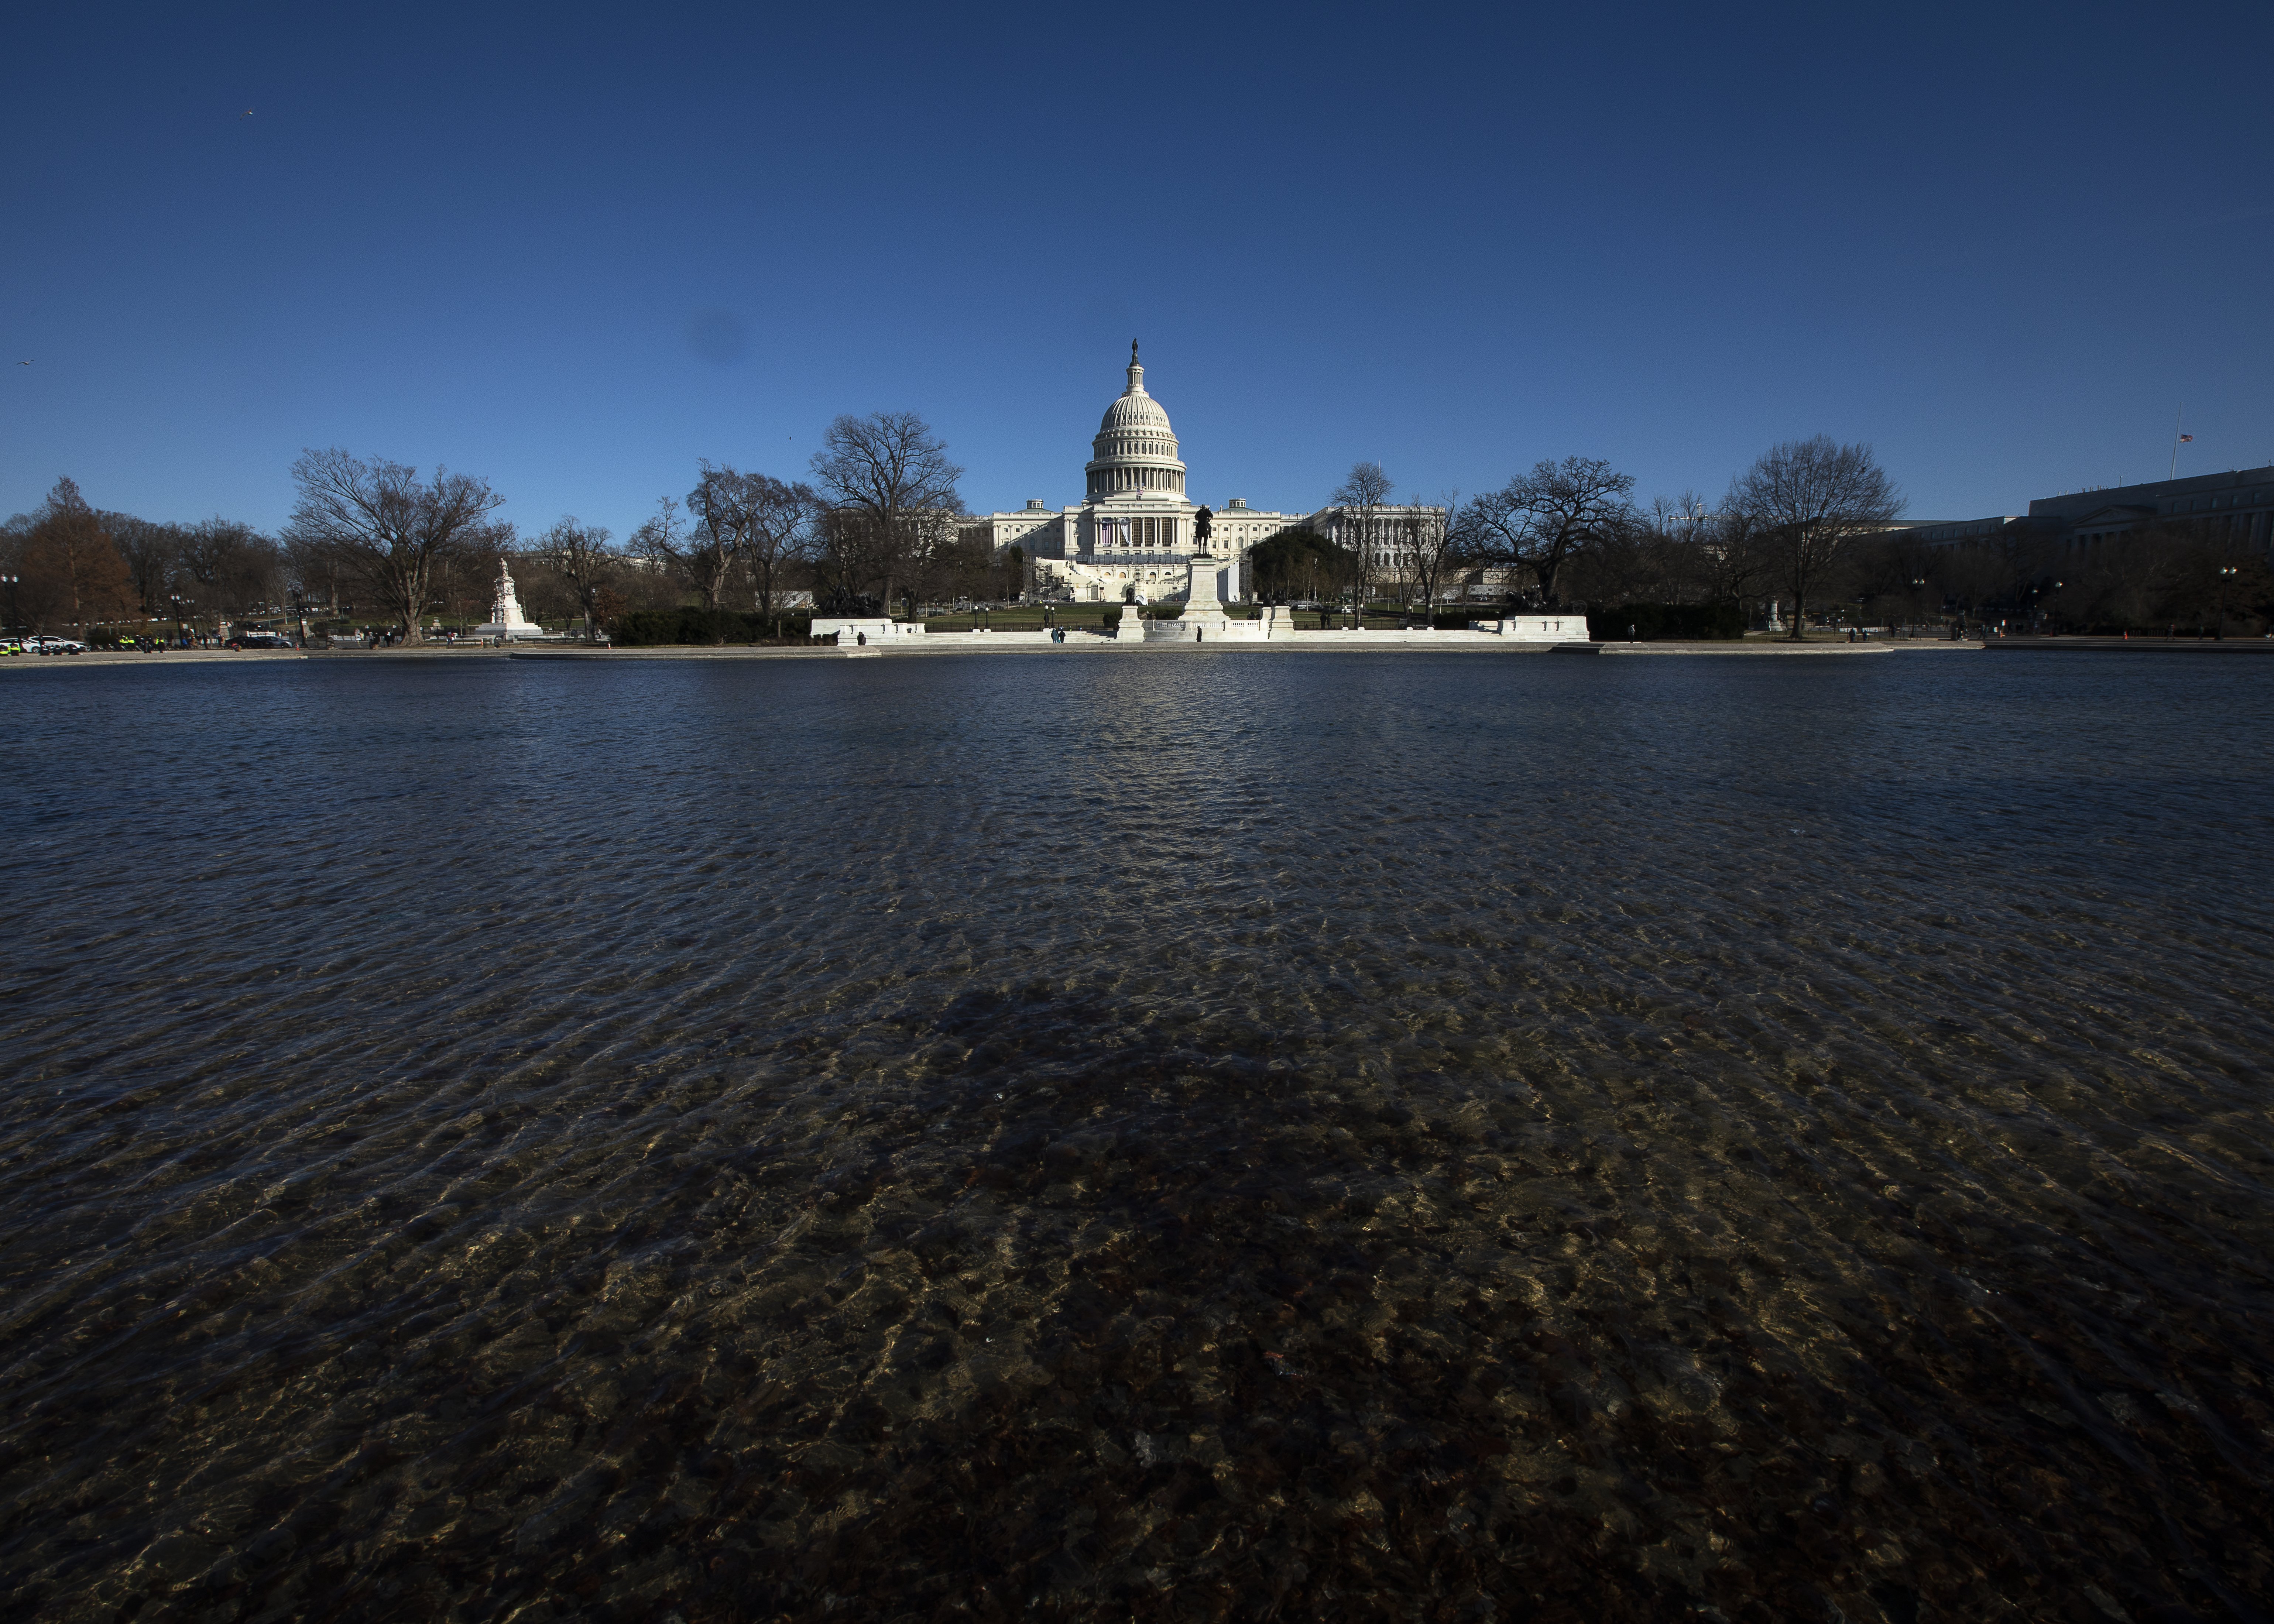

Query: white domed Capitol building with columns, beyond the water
[{"left": 971, "top": 343, "right": 1412, "bottom": 603}]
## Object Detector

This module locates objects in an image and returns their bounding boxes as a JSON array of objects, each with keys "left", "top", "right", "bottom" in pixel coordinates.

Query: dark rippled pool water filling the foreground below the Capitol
[{"left": 0, "top": 650, "right": 2274, "bottom": 1624}]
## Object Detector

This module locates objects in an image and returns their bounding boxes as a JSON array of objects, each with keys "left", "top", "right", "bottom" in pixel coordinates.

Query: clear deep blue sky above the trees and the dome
[{"left": 0, "top": 2, "right": 2274, "bottom": 535}]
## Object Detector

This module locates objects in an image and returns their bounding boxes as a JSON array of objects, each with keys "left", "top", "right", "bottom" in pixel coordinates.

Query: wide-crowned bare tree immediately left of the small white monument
[{"left": 284, "top": 446, "right": 514, "bottom": 644}]
